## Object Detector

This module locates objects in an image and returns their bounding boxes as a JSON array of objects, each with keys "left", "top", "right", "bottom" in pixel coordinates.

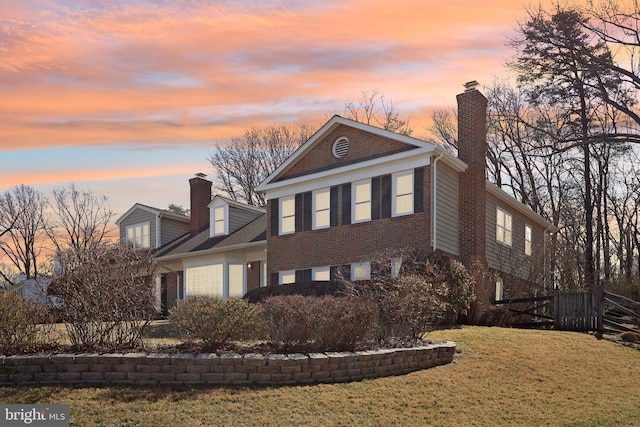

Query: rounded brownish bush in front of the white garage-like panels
[{"left": 169, "top": 296, "right": 261, "bottom": 351}]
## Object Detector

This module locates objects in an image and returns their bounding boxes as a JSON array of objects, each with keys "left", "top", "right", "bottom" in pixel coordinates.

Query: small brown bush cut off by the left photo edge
[{"left": 0, "top": 291, "right": 50, "bottom": 355}]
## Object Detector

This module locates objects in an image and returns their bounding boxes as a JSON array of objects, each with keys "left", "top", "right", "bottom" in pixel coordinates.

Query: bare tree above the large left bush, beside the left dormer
[{"left": 47, "top": 184, "right": 114, "bottom": 253}]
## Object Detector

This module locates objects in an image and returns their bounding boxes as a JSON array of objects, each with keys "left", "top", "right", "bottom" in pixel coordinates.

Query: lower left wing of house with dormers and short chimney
[{"left": 116, "top": 174, "right": 266, "bottom": 313}]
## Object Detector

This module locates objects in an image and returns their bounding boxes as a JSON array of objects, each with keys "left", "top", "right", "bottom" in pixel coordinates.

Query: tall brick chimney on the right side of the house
[{"left": 456, "top": 81, "right": 487, "bottom": 267}]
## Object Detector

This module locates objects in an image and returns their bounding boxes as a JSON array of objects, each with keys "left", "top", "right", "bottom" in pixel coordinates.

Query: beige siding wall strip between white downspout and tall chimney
[{"left": 435, "top": 162, "right": 460, "bottom": 256}]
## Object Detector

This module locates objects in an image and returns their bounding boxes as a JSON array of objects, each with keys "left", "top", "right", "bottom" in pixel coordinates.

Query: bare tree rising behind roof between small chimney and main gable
[{"left": 209, "top": 124, "right": 314, "bottom": 206}]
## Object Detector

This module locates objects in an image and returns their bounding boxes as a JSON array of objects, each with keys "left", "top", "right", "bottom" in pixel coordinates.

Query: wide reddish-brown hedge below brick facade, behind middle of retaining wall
[{"left": 263, "top": 295, "right": 377, "bottom": 352}]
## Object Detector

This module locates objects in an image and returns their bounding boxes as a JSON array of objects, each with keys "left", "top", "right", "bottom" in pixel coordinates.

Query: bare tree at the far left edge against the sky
[{"left": 0, "top": 185, "right": 47, "bottom": 280}]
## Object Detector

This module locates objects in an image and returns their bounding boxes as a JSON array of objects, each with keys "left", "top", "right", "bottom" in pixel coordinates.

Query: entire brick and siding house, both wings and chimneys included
[{"left": 118, "top": 82, "right": 557, "bottom": 308}]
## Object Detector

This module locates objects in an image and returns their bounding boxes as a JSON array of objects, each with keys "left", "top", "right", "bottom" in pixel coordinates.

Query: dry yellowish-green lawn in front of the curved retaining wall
[{"left": 0, "top": 327, "right": 640, "bottom": 426}]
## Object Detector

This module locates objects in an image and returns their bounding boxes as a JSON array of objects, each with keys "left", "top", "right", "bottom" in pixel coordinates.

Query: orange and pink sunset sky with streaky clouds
[{"left": 0, "top": 0, "right": 552, "bottom": 220}]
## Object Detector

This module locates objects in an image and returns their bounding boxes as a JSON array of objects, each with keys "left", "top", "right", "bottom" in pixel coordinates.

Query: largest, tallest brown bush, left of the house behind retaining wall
[{"left": 49, "top": 244, "right": 156, "bottom": 351}]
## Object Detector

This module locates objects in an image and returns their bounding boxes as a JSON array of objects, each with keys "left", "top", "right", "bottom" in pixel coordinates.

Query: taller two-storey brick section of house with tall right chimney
[{"left": 258, "top": 82, "right": 555, "bottom": 303}]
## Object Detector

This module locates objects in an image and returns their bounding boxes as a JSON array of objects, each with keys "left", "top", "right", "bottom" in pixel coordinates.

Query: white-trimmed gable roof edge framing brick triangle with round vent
[{"left": 257, "top": 115, "right": 467, "bottom": 192}]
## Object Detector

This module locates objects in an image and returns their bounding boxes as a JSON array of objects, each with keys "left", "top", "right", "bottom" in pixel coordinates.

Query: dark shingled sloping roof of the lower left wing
[{"left": 157, "top": 214, "right": 267, "bottom": 261}]
